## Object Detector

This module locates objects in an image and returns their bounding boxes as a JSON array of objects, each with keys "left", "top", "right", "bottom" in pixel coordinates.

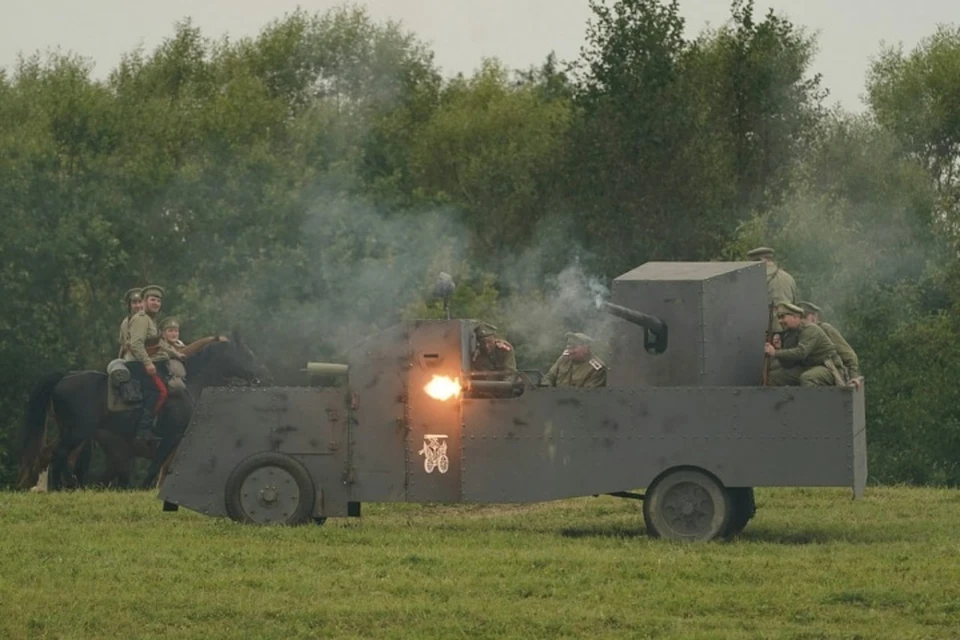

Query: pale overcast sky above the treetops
[{"left": 0, "top": 0, "right": 960, "bottom": 111}]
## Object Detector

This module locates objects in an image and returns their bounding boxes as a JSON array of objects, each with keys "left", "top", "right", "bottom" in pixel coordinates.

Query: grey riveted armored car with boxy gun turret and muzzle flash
[{"left": 160, "top": 262, "right": 867, "bottom": 540}]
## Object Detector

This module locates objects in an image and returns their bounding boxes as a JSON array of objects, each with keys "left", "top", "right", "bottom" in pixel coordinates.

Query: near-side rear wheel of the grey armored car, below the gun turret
[{"left": 643, "top": 469, "right": 731, "bottom": 542}]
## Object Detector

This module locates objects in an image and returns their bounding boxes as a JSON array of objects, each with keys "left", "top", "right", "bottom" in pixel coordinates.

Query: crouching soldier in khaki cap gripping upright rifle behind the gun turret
[{"left": 763, "top": 303, "right": 842, "bottom": 387}]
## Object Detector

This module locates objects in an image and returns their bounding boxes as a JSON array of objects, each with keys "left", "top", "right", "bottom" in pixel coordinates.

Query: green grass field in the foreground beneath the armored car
[{"left": 0, "top": 487, "right": 960, "bottom": 640}]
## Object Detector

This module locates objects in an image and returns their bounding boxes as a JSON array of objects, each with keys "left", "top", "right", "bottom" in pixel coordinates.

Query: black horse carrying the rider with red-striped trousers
[{"left": 18, "top": 335, "right": 266, "bottom": 490}]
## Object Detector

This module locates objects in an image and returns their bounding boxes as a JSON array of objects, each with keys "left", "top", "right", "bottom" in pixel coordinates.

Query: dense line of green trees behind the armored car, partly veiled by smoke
[{"left": 0, "top": 0, "right": 960, "bottom": 485}]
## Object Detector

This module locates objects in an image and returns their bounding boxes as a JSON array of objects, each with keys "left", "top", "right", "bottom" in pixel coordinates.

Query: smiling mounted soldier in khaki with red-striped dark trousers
[{"left": 125, "top": 285, "right": 170, "bottom": 440}]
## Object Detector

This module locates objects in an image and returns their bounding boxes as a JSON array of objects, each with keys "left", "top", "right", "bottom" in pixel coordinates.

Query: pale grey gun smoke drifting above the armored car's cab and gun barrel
[{"left": 218, "top": 191, "right": 616, "bottom": 384}]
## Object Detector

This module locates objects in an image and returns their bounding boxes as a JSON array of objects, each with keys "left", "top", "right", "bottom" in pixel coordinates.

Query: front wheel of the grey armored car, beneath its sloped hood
[{"left": 226, "top": 451, "right": 316, "bottom": 525}]
